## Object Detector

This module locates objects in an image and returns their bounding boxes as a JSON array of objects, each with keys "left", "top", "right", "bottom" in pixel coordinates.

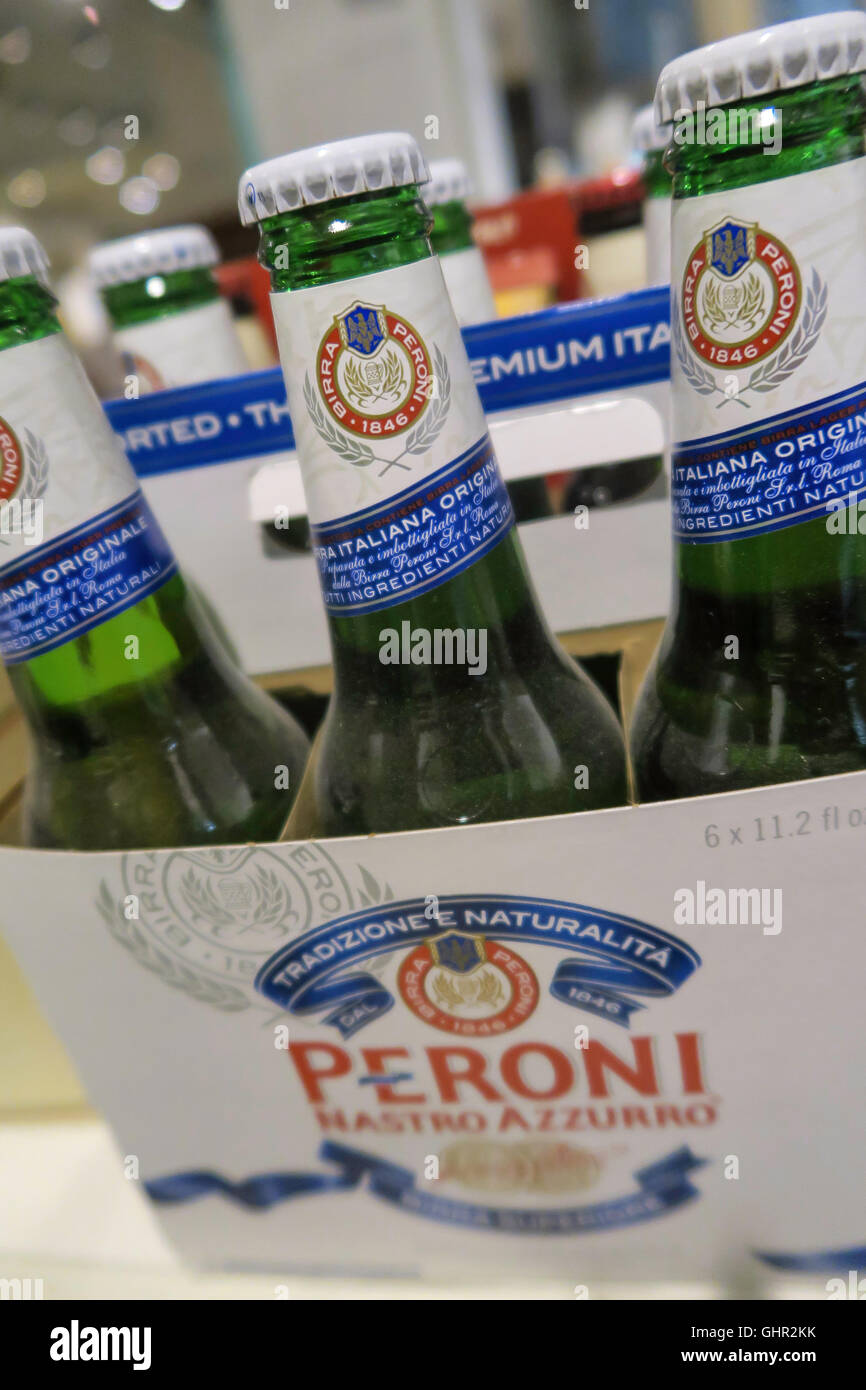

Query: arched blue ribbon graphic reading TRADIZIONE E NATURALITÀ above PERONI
[{"left": 256, "top": 894, "right": 701, "bottom": 1038}]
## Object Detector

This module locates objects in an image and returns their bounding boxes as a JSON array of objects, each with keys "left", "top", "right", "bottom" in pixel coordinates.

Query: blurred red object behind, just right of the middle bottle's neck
[{"left": 473, "top": 188, "right": 581, "bottom": 300}]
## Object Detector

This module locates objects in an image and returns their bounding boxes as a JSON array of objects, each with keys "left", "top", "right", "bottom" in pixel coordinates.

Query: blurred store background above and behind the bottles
[{"left": 0, "top": 0, "right": 856, "bottom": 352}]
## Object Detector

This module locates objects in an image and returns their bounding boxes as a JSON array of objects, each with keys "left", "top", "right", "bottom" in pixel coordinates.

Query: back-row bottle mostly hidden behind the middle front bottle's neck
[{"left": 421, "top": 160, "right": 496, "bottom": 328}]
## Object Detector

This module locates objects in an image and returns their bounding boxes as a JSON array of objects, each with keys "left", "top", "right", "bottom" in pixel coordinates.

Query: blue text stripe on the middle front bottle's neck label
[{"left": 311, "top": 435, "right": 514, "bottom": 614}]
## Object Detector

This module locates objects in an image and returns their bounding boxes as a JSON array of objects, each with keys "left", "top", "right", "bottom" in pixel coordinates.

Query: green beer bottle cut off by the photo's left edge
[{"left": 0, "top": 228, "right": 307, "bottom": 849}]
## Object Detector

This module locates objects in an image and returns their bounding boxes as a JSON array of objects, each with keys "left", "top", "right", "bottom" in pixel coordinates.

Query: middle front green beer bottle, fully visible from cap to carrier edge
[{"left": 239, "top": 135, "right": 626, "bottom": 835}]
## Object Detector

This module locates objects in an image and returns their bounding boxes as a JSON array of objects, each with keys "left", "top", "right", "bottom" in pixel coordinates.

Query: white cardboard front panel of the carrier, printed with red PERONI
[{"left": 0, "top": 773, "right": 866, "bottom": 1283}]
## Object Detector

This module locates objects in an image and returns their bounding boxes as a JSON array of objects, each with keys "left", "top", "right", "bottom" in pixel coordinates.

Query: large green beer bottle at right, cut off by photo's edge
[{"left": 631, "top": 13, "right": 866, "bottom": 801}]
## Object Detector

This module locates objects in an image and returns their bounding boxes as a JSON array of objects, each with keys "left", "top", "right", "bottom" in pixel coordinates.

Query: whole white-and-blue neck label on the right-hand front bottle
[{"left": 671, "top": 158, "right": 866, "bottom": 542}]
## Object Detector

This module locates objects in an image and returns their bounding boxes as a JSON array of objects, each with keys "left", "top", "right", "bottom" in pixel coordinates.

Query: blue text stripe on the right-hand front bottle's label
[{"left": 671, "top": 382, "right": 866, "bottom": 545}]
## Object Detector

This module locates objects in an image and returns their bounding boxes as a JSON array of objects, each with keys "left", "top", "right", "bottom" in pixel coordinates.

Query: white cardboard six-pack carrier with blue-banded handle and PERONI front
[{"left": 0, "top": 289, "right": 866, "bottom": 1286}]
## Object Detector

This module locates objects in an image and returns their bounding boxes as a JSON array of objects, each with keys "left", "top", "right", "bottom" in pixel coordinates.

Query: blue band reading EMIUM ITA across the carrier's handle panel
[{"left": 106, "top": 285, "right": 670, "bottom": 478}]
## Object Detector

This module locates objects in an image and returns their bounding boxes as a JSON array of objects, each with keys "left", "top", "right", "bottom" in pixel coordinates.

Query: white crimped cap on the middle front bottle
[{"left": 238, "top": 132, "right": 430, "bottom": 227}]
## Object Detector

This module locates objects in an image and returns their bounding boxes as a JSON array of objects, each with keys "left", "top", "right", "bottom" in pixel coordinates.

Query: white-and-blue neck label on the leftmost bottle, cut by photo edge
[{"left": 0, "top": 334, "right": 177, "bottom": 664}]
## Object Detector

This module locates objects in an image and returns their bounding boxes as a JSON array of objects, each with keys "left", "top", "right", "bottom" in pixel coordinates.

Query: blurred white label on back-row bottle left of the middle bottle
[{"left": 114, "top": 299, "right": 250, "bottom": 395}]
